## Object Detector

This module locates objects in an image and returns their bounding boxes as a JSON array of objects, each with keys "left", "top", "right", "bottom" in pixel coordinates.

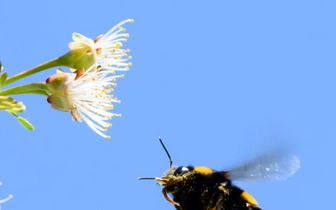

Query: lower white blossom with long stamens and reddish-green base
[{"left": 46, "top": 66, "right": 124, "bottom": 139}]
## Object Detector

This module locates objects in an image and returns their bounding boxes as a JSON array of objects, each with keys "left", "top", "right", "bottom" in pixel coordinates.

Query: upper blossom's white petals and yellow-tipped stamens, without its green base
[{"left": 69, "top": 19, "right": 134, "bottom": 74}]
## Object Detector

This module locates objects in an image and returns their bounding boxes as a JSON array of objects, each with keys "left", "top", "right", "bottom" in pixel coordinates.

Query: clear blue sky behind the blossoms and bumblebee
[{"left": 0, "top": 0, "right": 336, "bottom": 210}]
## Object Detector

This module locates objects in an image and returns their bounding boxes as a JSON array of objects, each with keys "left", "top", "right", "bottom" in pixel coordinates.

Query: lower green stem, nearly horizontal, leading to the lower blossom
[{"left": 0, "top": 82, "right": 49, "bottom": 97}]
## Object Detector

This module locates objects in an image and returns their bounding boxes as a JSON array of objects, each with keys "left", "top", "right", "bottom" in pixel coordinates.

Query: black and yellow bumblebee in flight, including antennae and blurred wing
[{"left": 138, "top": 138, "right": 300, "bottom": 210}]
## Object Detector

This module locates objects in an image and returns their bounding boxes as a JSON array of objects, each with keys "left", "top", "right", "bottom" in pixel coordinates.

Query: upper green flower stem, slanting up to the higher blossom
[{"left": 5, "top": 58, "right": 61, "bottom": 85}]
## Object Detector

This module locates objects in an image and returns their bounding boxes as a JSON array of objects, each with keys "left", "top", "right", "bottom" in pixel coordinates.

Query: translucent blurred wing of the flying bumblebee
[{"left": 226, "top": 152, "right": 300, "bottom": 181}]
